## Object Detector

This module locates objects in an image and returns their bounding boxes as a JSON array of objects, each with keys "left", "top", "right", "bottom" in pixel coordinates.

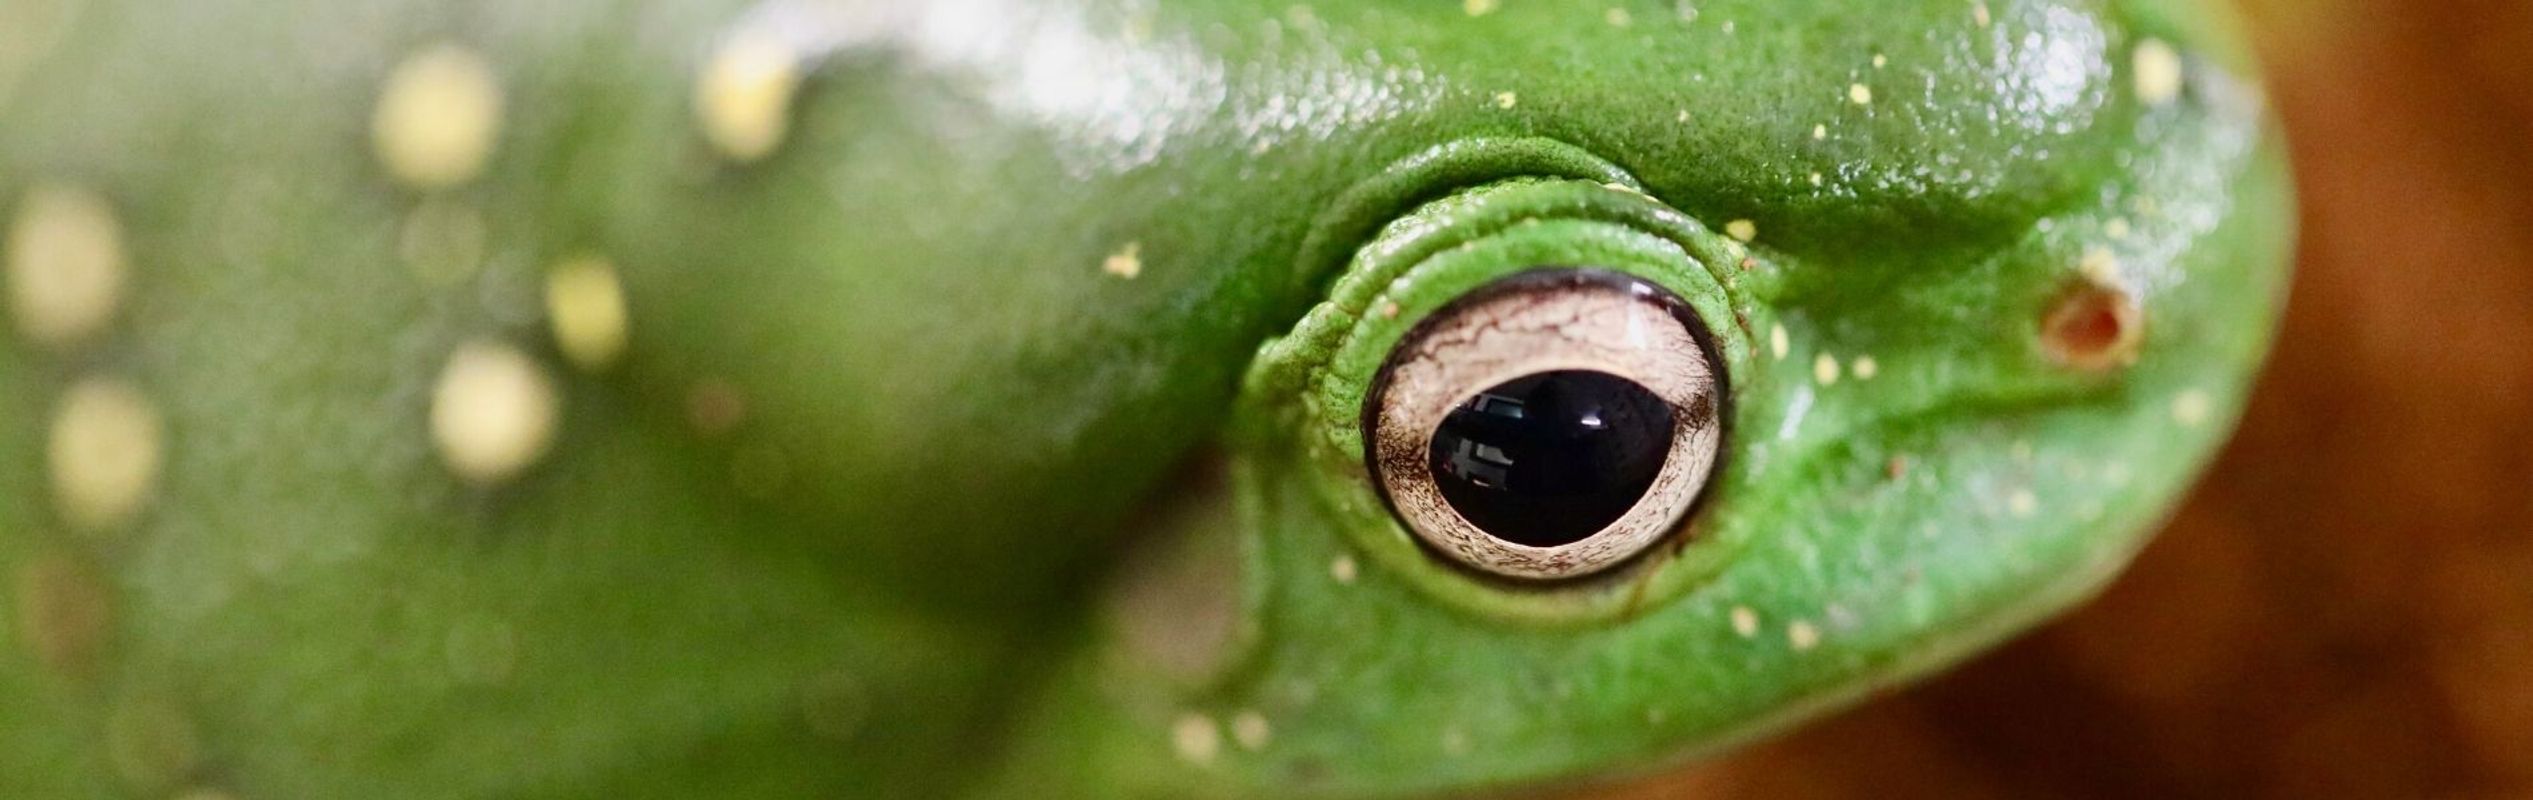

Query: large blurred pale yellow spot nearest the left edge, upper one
[{"left": 8, "top": 185, "right": 124, "bottom": 347}]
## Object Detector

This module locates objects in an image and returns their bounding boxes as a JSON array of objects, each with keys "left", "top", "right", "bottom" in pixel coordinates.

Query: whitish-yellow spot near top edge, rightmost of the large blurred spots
[{"left": 694, "top": 30, "right": 800, "bottom": 165}]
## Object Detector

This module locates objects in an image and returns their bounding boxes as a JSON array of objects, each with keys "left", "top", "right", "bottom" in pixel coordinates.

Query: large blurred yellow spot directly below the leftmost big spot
[{"left": 46, "top": 377, "right": 165, "bottom": 532}]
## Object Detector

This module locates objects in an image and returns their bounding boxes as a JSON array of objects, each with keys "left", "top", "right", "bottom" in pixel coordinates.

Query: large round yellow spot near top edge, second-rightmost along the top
[{"left": 370, "top": 43, "right": 502, "bottom": 190}]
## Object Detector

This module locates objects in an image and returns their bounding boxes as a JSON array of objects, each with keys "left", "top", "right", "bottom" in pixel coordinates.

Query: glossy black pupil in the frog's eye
[{"left": 1431, "top": 370, "right": 1672, "bottom": 547}]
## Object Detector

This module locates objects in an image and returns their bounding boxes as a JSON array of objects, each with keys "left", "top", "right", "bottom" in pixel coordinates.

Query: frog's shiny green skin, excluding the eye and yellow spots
[{"left": 0, "top": 0, "right": 2290, "bottom": 797}]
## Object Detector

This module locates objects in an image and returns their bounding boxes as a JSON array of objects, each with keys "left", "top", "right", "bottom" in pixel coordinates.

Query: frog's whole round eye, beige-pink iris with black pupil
[{"left": 1363, "top": 268, "right": 1725, "bottom": 580}]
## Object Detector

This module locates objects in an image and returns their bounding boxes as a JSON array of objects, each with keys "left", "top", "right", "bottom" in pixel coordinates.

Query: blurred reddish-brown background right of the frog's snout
[{"left": 1596, "top": 0, "right": 2533, "bottom": 800}]
